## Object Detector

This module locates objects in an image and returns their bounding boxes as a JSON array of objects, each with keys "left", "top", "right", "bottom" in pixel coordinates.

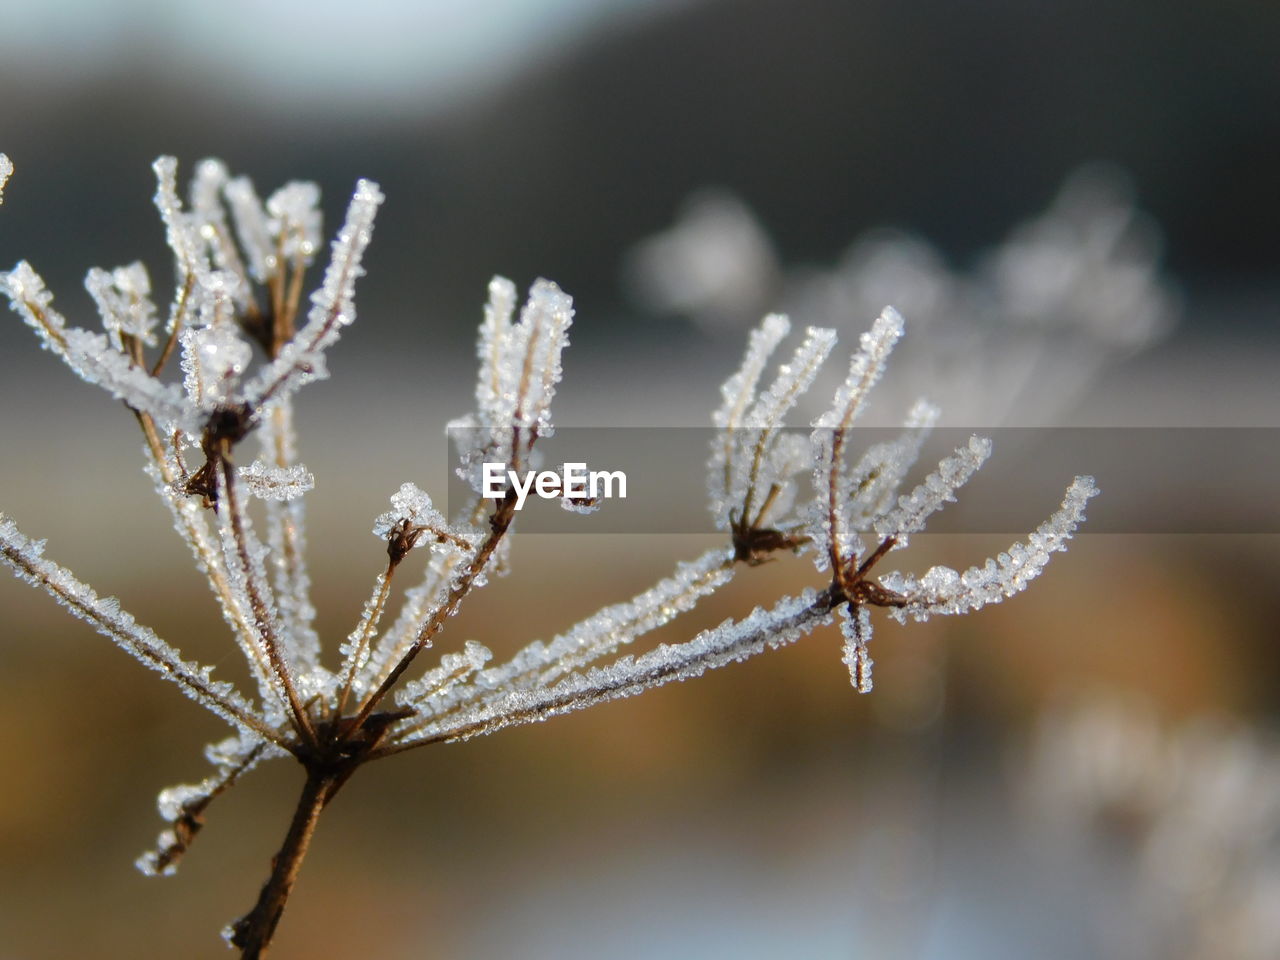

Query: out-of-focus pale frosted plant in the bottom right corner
[{"left": 1024, "top": 691, "right": 1280, "bottom": 960}]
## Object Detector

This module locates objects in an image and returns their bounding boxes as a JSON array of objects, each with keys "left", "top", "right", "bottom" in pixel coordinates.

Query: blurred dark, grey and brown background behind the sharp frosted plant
[{"left": 0, "top": 0, "right": 1280, "bottom": 960}]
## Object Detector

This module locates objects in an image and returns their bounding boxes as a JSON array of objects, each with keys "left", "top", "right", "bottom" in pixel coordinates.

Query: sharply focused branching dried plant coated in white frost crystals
[{"left": 0, "top": 157, "right": 1094, "bottom": 957}]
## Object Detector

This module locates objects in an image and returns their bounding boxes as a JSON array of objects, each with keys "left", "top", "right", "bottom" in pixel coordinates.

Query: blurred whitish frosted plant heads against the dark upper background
[{"left": 630, "top": 165, "right": 1179, "bottom": 425}]
